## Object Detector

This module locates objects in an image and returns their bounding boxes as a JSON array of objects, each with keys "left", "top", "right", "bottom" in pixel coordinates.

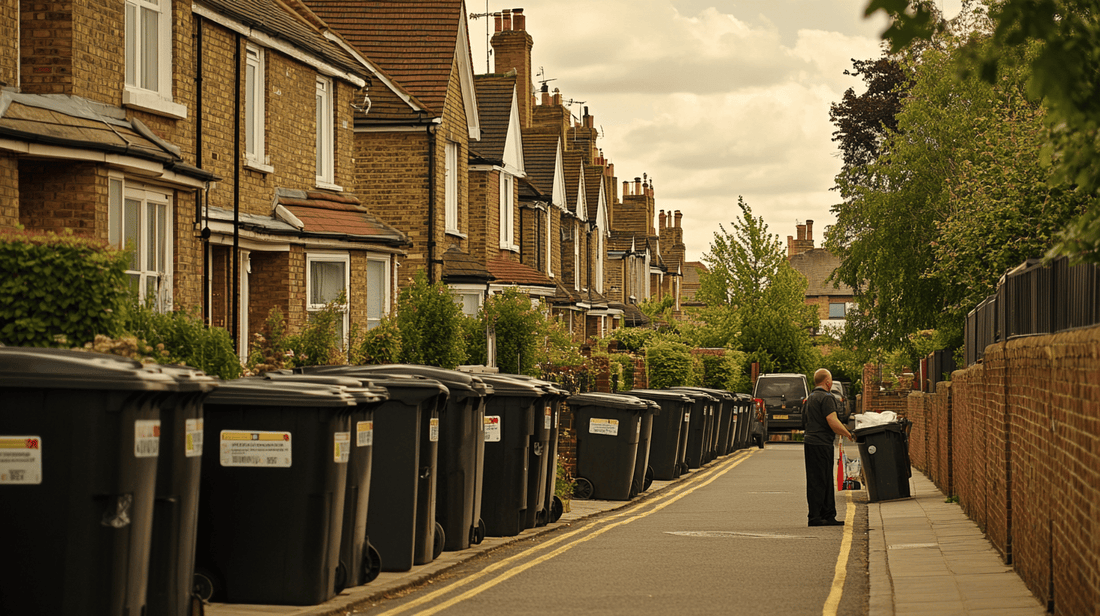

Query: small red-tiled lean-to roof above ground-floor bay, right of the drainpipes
[{"left": 275, "top": 188, "right": 408, "bottom": 245}]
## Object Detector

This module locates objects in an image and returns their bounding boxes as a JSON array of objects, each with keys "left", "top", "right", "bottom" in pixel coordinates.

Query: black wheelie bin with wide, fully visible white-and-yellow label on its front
[{"left": 195, "top": 377, "right": 356, "bottom": 605}]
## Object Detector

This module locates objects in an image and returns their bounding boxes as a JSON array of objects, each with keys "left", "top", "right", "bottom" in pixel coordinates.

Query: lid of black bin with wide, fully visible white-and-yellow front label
[{"left": 206, "top": 376, "right": 358, "bottom": 408}]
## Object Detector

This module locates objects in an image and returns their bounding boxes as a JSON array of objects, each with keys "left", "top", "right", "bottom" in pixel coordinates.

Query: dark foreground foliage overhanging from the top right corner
[{"left": 866, "top": 0, "right": 1100, "bottom": 263}]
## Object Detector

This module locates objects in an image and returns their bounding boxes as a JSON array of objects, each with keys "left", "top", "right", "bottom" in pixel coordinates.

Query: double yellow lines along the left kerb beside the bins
[{"left": 378, "top": 450, "right": 755, "bottom": 616}]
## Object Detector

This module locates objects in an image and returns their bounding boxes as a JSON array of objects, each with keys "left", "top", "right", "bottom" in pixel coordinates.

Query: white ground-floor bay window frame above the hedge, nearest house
[{"left": 108, "top": 176, "right": 175, "bottom": 312}]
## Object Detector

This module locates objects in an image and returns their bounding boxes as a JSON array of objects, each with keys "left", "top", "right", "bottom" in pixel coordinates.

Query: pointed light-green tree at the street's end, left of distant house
[{"left": 699, "top": 198, "right": 818, "bottom": 372}]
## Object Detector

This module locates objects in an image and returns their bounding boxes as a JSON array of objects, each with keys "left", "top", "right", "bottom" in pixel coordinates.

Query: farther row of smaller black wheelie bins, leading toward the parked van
[{"left": 568, "top": 387, "right": 752, "bottom": 501}]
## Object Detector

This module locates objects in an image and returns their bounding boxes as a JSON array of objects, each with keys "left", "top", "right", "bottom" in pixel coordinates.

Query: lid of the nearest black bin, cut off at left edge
[{"left": 0, "top": 347, "right": 179, "bottom": 392}]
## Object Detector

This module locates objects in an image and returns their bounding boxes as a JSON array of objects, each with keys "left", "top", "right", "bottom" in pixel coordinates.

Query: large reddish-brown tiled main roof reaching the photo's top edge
[{"left": 305, "top": 0, "right": 466, "bottom": 113}]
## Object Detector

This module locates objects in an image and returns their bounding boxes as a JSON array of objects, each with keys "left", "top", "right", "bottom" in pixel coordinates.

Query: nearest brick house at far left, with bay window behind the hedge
[{"left": 0, "top": 0, "right": 219, "bottom": 310}]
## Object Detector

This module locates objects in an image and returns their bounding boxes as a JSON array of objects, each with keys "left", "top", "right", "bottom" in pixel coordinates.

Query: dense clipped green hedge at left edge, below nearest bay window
[{"left": 0, "top": 231, "right": 130, "bottom": 347}]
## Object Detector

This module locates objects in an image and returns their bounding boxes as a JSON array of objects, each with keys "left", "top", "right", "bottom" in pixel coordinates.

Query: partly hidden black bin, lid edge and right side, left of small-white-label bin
[{"left": 349, "top": 364, "right": 492, "bottom": 551}]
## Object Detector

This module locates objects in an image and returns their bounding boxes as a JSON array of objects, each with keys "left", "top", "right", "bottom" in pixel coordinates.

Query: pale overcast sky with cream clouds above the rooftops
[{"left": 466, "top": 0, "right": 959, "bottom": 261}]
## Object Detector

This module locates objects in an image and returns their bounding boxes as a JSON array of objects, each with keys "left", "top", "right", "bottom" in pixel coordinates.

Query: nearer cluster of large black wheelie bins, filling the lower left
[{"left": 0, "top": 348, "right": 569, "bottom": 615}]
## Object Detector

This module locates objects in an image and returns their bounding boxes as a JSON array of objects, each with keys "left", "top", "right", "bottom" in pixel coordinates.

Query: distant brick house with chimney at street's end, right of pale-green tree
[{"left": 787, "top": 220, "right": 856, "bottom": 333}]
